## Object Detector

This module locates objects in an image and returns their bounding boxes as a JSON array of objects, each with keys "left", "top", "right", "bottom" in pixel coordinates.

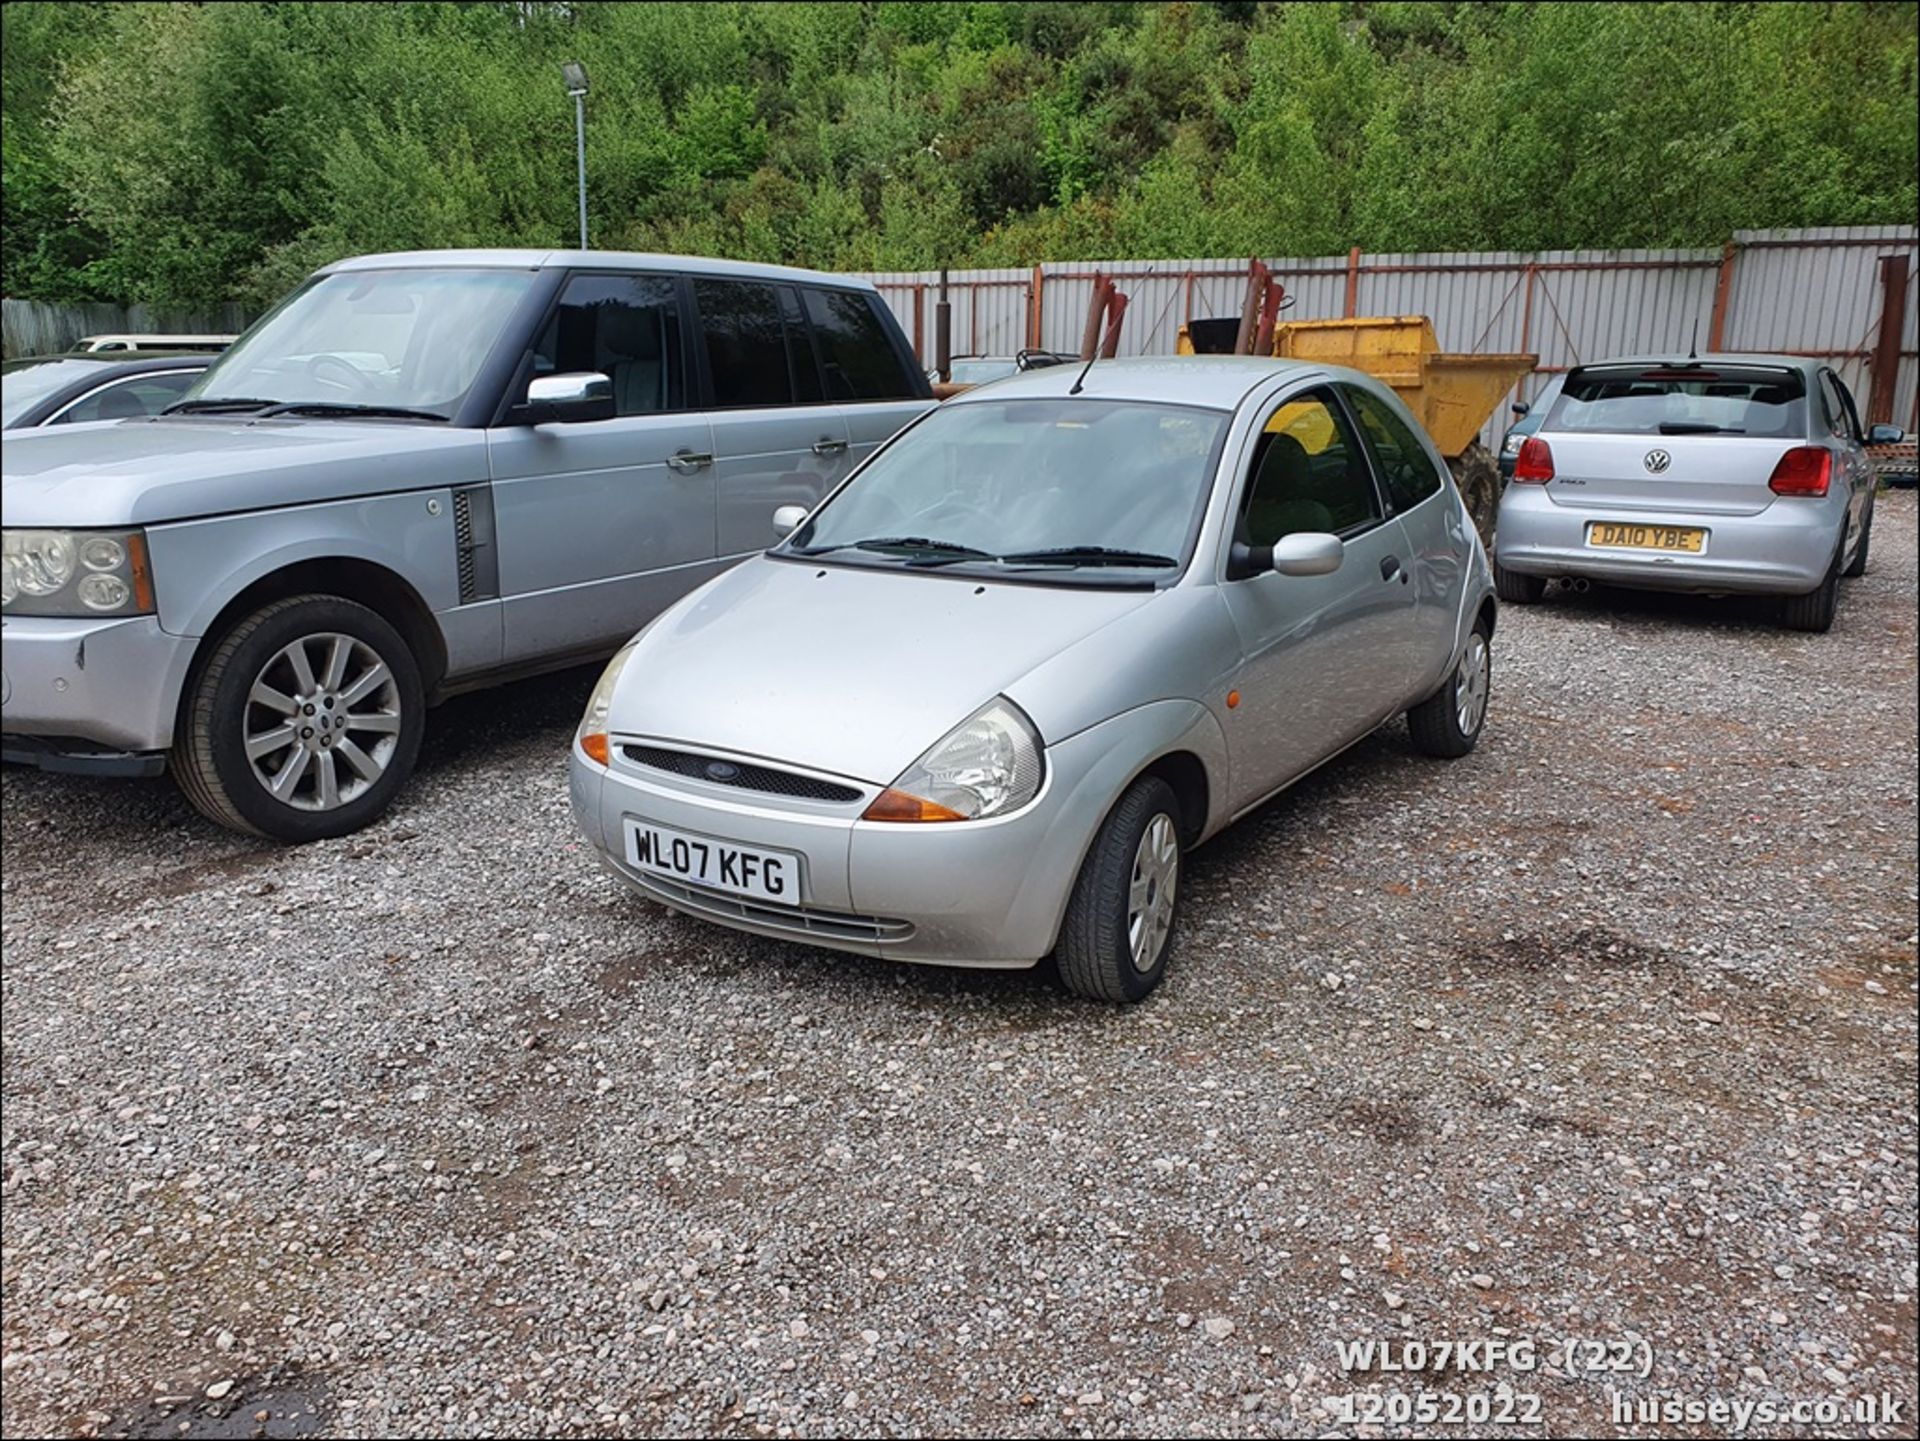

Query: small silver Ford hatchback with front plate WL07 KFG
[{"left": 572, "top": 359, "right": 1494, "bottom": 1002}]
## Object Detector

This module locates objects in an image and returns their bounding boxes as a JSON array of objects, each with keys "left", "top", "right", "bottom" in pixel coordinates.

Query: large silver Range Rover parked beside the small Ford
[{"left": 0, "top": 249, "right": 933, "bottom": 840}]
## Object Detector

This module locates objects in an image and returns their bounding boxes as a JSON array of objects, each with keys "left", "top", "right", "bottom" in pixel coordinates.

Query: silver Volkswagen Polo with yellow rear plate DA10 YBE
[{"left": 1494, "top": 355, "right": 1899, "bottom": 631}]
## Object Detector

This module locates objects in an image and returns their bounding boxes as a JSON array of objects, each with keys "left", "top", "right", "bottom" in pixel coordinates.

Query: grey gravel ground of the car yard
[{"left": 0, "top": 491, "right": 1920, "bottom": 1435}]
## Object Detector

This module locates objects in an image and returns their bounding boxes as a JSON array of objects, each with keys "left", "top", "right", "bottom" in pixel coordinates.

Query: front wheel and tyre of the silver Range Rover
[{"left": 171, "top": 595, "right": 426, "bottom": 840}]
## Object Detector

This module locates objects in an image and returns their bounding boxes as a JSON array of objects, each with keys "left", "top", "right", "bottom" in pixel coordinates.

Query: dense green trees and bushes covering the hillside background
[{"left": 0, "top": 0, "right": 1920, "bottom": 307}]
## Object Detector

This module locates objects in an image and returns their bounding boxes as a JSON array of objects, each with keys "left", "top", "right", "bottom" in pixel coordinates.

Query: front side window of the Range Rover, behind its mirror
[{"left": 534, "top": 274, "right": 687, "bottom": 414}]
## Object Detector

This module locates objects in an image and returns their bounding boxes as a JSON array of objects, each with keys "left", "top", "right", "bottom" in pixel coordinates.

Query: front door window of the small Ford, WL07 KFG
[{"left": 1238, "top": 390, "right": 1384, "bottom": 545}]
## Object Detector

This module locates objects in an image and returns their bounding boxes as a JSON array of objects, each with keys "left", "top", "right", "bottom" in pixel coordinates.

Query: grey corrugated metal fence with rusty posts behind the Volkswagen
[{"left": 868, "top": 226, "right": 1920, "bottom": 439}]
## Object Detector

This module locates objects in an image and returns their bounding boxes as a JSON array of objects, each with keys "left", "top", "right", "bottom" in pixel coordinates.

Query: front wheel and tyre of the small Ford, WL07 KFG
[{"left": 1054, "top": 775, "right": 1181, "bottom": 1002}]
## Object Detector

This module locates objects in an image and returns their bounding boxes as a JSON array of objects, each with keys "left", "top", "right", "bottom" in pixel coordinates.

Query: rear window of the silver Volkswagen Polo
[{"left": 1542, "top": 363, "right": 1807, "bottom": 437}]
